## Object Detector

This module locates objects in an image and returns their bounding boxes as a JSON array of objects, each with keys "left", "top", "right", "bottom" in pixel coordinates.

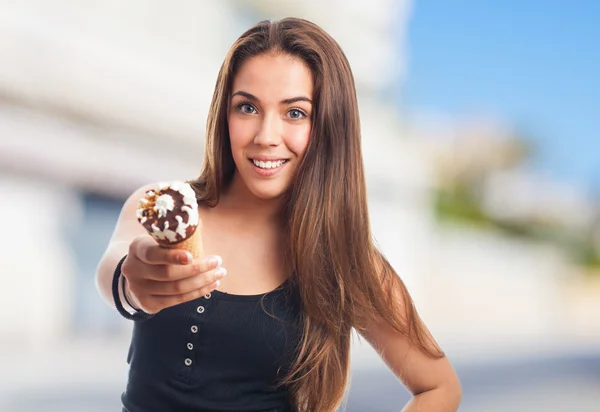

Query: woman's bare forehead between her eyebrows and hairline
[{"left": 232, "top": 54, "right": 313, "bottom": 101}]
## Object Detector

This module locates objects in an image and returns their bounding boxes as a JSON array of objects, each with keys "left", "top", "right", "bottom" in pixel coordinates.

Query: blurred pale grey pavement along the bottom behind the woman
[{"left": 0, "top": 337, "right": 600, "bottom": 412}]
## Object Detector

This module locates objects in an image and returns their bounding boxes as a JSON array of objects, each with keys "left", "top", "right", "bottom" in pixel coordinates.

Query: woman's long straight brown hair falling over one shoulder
[{"left": 191, "top": 18, "right": 443, "bottom": 412}]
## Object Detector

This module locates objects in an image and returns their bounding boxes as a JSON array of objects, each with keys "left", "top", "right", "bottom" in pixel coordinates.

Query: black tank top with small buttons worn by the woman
[{"left": 121, "top": 272, "right": 302, "bottom": 412}]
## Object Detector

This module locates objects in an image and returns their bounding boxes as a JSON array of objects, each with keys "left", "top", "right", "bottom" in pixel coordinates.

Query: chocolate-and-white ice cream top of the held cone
[{"left": 137, "top": 182, "right": 198, "bottom": 245}]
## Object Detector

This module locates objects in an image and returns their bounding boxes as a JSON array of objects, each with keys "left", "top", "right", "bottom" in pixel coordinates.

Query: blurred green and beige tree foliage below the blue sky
[{"left": 433, "top": 123, "right": 600, "bottom": 274}]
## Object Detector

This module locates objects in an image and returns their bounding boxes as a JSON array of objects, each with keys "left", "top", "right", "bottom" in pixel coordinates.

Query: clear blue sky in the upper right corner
[{"left": 401, "top": 0, "right": 600, "bottom": 191}]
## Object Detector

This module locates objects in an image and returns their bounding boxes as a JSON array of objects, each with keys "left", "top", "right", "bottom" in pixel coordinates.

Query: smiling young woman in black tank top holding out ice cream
[{"left": 97, "top": 19, "right": 461, "bottom": 412}]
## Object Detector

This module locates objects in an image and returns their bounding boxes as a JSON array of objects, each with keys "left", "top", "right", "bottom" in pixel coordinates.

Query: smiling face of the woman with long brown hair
[{"left": 228, "top": 54, "right": 313, "bottom": 200}]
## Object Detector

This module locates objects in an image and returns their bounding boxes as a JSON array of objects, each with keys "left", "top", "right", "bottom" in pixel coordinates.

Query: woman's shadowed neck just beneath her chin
[{"left": 219, "top": 173, "right": 282, "bottom": 225}]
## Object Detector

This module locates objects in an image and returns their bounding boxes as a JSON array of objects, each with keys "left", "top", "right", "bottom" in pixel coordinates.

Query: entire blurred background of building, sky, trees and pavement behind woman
[{"left": 0, "top": 0, "right": 600, "bottom": 412}]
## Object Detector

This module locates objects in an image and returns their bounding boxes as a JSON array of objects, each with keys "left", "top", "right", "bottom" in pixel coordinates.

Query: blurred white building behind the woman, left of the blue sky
[{"left": 0, "top": 0, "right": 438, "bottom": 346}]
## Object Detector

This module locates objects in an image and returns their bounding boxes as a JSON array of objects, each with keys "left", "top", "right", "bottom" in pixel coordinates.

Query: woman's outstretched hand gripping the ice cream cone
[{"left": 121, "top": 235, "right": 227, "bottom": 314}]
